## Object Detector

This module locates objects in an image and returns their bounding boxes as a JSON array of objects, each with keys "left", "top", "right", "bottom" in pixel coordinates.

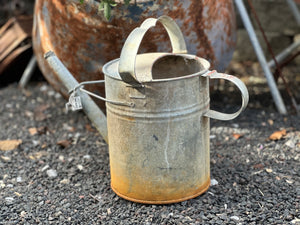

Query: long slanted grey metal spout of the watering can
[{"left": 44, "top": 51, "right": 108, "bottom": 143}]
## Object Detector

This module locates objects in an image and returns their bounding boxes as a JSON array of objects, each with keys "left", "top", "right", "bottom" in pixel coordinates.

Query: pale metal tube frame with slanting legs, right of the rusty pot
[{"left": 235, "top": 0, "right": 300, "bottom": 114}]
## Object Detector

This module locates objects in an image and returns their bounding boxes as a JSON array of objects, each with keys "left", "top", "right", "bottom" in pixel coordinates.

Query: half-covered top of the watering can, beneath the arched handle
[{"left": 103, "top": 53, "right": 210, "bottom": 83}]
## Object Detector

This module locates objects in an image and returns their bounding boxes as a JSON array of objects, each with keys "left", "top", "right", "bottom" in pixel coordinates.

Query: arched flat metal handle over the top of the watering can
[{"left": 119, "top": 16, "right": 187, "bottom": 83}]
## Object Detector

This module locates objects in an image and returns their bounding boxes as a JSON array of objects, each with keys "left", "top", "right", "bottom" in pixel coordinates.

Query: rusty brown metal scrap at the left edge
[{"left": 0, "top": 16, "right": 33, "bottom": 74}]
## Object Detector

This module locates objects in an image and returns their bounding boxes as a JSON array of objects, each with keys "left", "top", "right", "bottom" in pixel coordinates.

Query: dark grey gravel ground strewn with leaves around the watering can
[{"left": 0, "top": 78, "right": 300, "bottom": 224}]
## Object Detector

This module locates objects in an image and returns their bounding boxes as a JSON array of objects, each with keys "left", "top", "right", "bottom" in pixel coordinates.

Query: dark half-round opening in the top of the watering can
[{"left": 151, "top": 54, "right": 210, "bottom": 80}]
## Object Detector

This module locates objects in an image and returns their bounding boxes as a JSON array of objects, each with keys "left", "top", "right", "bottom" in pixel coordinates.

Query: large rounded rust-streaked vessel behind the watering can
[{"left": 33, "top": 0, "right": 236, "bottom": 109}]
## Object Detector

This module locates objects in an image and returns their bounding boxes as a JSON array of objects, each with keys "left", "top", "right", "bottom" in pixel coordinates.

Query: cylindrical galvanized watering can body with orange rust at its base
[{"left": 104, "top": 53, "right": 210, "bottom": 204}]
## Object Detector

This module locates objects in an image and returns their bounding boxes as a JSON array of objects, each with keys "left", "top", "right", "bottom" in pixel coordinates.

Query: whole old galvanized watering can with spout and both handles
[{"left": 46, "top": 16, "right": 249, "bottom": 204}]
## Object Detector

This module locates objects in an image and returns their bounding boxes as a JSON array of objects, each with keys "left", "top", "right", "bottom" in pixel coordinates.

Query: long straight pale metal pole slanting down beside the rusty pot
[{"left": 235, "top": 0, "right": 287, "bottom": 114}]
